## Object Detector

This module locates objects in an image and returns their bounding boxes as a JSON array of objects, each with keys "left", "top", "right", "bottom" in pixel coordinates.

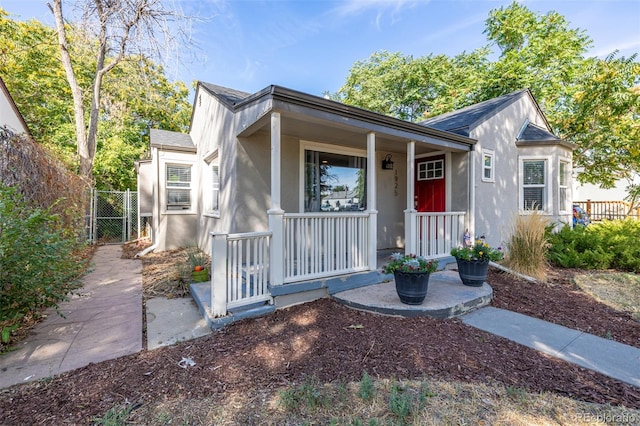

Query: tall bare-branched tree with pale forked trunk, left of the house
[{"left": 50, "top": 0, "right": 192, "bottom": 179}]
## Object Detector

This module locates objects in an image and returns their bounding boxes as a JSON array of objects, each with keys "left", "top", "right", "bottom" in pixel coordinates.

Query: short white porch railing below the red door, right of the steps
[{"left": 411, "top": 212, "right": 465, "bottom": 258}]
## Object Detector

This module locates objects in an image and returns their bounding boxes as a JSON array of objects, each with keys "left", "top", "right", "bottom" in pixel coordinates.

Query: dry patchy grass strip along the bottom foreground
[{"left": 129, "top": 379, "right": 640, "bottom": 426}]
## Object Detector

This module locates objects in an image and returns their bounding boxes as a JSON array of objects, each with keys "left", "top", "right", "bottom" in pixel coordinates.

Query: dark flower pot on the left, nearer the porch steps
[{"left": 382, "top": 253, "right": 438, "bottom": 305}]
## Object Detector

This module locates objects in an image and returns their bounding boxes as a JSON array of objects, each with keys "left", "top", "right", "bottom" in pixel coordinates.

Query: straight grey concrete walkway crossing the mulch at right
[{"left": 462, "top": 307, "right": 640, "bottom": 387}]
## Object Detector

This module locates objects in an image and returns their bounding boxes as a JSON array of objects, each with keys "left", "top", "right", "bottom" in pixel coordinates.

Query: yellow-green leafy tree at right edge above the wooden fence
[{"left": 558, "top": 53, "right": 640, "bottom": 205}]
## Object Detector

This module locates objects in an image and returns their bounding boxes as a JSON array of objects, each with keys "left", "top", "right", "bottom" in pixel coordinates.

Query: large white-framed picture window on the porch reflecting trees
[{"left": 304, "top": 149, "right": 367, "bottom": 212}]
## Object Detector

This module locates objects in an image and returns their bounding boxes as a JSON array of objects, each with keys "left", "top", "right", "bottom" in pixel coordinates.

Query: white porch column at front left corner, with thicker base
[{"left": 267, "top": 112, "right": 284, "bottom": 285}]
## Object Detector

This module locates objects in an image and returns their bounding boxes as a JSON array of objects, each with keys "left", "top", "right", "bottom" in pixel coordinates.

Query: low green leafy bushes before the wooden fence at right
[{"left": 548, "top": 219, "right": 640, "bottom": 272}]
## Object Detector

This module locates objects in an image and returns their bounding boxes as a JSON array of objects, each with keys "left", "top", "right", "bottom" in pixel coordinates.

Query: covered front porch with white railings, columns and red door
[{"left": 209, "top": 92, "right": 474, "bottom": 317}]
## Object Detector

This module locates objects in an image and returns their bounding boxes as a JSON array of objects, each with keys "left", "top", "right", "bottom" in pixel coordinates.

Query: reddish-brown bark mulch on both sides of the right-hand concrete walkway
[{"left": 0, "top": 262, "right": 640, "bottom": 424}]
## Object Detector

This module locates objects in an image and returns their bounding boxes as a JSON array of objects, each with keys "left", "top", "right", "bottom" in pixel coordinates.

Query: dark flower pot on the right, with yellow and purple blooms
[{"left": 451, "top": 240, "right": 504, "bottom": 287}]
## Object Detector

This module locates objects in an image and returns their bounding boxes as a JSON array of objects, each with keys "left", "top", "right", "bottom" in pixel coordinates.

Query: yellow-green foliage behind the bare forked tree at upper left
[{"left": 0, "top": 9, "right": 191, "bottom": 190}]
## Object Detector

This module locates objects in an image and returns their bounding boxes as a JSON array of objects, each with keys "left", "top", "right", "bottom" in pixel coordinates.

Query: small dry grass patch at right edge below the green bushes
[{"left": 575, "top": 272, "right": 640, "bottom": 320}]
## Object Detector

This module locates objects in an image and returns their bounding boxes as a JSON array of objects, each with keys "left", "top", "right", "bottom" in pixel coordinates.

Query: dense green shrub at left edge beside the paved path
[{"left": 0, "top": 185, "right": 86, "bottom": 343}]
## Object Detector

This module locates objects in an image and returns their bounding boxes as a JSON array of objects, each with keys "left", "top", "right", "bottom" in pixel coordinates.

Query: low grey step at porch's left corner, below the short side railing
[{"left": 190, "top": 282, "right": 276, "bottom": 330}]
